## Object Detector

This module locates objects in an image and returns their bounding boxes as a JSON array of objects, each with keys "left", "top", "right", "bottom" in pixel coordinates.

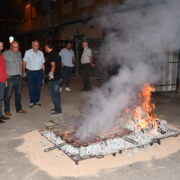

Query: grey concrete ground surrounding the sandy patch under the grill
[{"left": 0, "top": 81, "right": 180, "bottom": 180}]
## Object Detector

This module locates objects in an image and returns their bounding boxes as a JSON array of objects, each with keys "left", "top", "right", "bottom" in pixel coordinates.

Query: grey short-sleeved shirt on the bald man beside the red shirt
[{"left": 3, "top": 50, "right": 22, "bottom": 76}]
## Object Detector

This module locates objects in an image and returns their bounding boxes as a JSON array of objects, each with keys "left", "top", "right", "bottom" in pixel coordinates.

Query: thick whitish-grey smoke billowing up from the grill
[{"left": 76, "top": 0, "right": 180, "bottom": 140}]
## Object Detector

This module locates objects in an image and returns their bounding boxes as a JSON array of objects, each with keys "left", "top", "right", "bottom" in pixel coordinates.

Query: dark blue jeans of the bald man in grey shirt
[{"left": 4, "top": 75, "right": 22, "bottom": 112}]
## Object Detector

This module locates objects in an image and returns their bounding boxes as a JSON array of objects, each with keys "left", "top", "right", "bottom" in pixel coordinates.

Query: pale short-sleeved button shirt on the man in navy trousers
[{"left": 23, "top": 49, "right": 45, "bottom": 71}]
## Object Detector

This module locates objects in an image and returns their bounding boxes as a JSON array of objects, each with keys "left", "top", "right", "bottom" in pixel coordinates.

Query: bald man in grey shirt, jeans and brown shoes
[{"left": 3, "top": 41, "right": 27, "bottom": 116}]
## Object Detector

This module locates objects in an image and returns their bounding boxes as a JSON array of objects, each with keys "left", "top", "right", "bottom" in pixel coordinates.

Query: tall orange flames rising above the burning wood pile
[{"left": 133, "top": 84, "right": 158, "bottom": 129}]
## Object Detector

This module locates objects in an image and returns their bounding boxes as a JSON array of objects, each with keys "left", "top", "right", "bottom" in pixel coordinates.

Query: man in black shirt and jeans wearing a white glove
[{"left": 45, "top": 42, "right": 62, "bottom": 116}]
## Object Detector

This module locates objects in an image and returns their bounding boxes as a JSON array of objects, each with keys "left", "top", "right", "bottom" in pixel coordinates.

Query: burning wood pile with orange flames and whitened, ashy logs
[{"left": 116, "top": 84, "right": 167, "bottom": 133}]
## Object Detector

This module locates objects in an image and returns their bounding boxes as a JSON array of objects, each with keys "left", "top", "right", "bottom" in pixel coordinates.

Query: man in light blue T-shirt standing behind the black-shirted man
[{"left": 59, "top": 42, "right": 75, "bottom": 91}]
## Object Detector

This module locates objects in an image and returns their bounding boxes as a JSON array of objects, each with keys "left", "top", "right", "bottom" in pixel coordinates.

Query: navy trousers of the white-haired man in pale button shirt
[{"left": 27, "top": 70, "right": 43, "bottom": 104}]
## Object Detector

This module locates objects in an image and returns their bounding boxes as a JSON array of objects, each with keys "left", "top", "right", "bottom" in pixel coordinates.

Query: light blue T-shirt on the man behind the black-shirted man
[{"left": 59, "top": 48, "right": 74, "bottom": 67}]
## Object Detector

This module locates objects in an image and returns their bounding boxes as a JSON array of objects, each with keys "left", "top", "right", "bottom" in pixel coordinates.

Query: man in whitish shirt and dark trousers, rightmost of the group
[{"left": 81, "top": 41, "right": 95, "bottom": 91}]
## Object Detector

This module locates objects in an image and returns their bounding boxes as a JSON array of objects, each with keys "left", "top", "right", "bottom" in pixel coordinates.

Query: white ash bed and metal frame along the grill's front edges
[{"left": 39, "top": 120, "right": 179, "bottom": 164}]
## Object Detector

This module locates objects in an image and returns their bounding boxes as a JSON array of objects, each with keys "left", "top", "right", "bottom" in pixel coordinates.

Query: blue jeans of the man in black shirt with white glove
[{"left": 47, "top": 80, "right": 62, "bottom": 113}]
